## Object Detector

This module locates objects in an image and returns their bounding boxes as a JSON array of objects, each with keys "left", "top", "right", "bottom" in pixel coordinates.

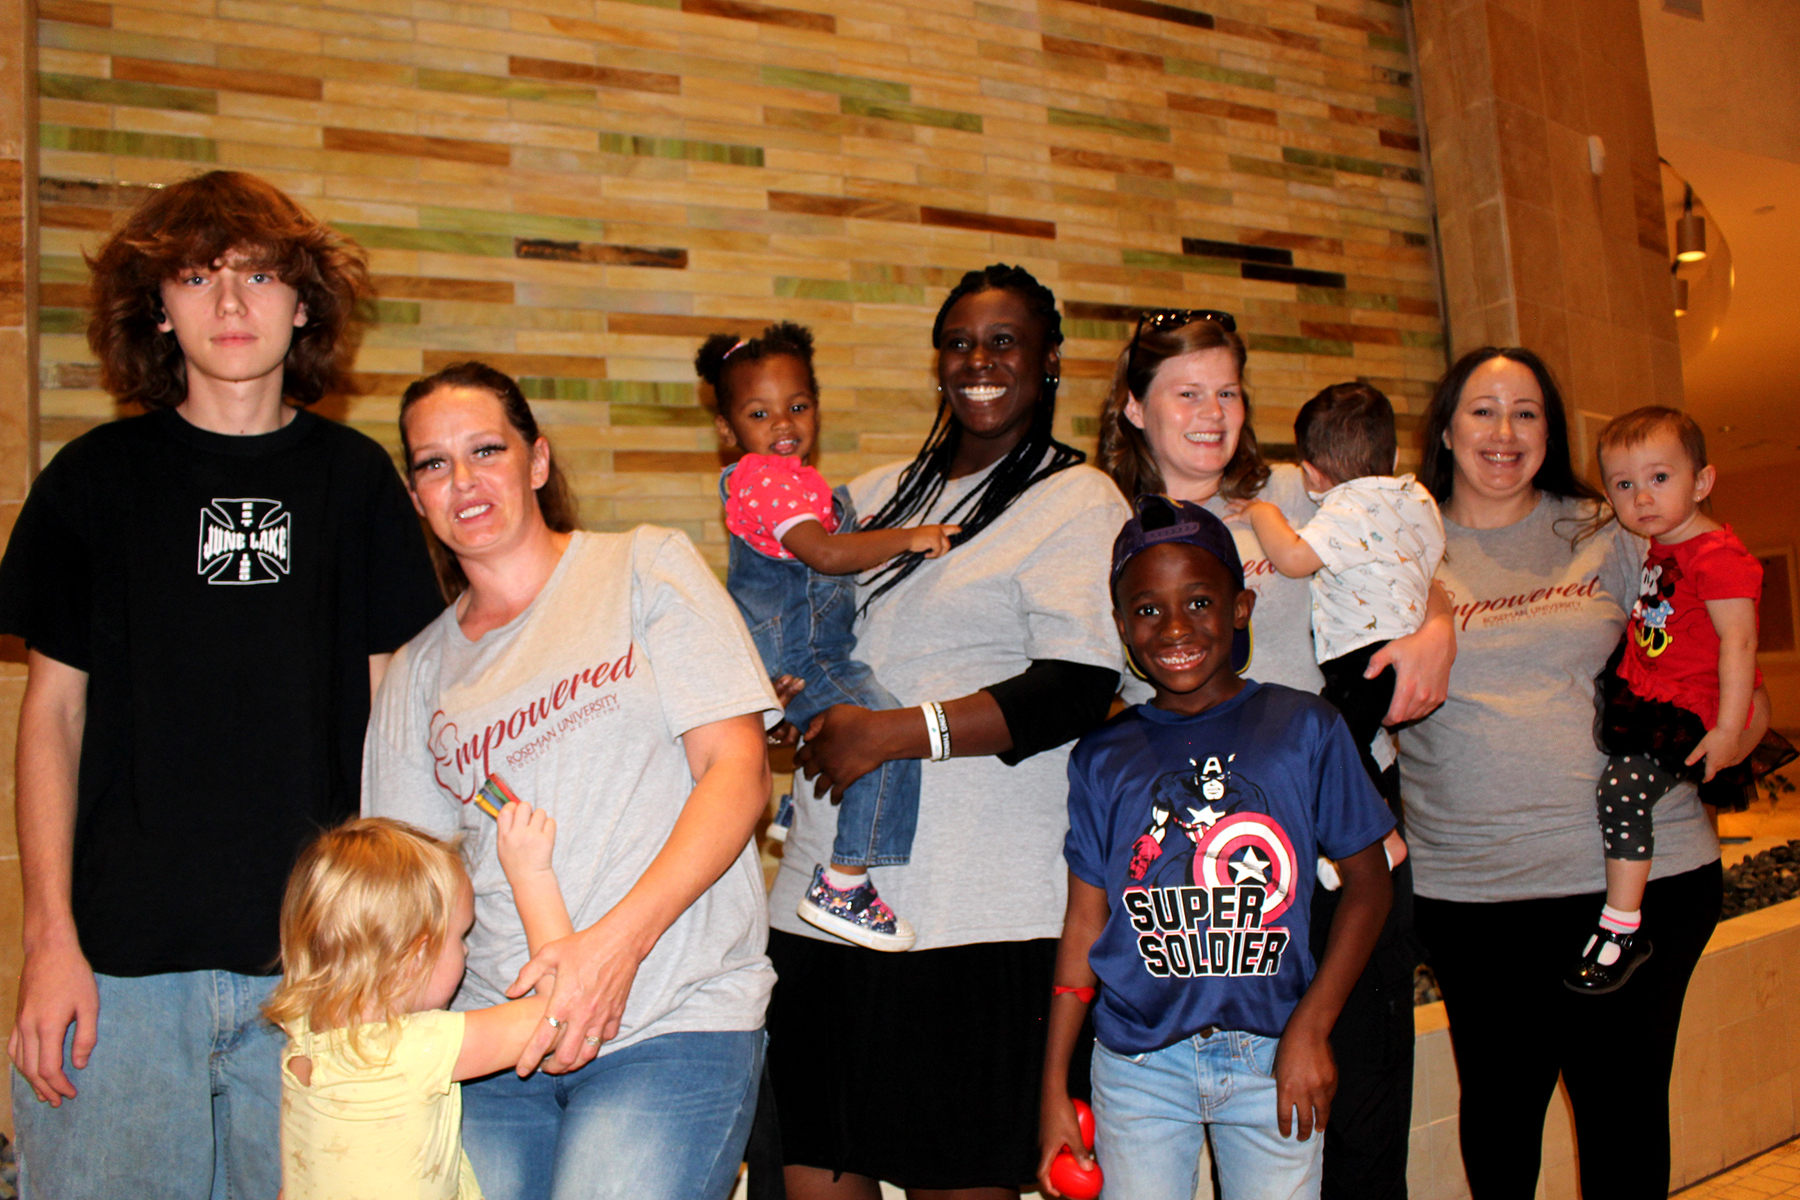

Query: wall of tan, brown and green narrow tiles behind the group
[{"left": 38, "top": 0, "right": 1442, "bottom": 561}]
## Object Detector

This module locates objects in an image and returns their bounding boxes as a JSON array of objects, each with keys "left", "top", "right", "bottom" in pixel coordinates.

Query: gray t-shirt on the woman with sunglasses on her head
[{"left": 1120, "top": 462, "right": 1325, "bottom": 703}]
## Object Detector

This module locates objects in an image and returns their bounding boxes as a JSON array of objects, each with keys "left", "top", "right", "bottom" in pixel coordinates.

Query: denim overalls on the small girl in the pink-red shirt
[{"left": 718, "top": 466, "right": 920, "bottom": 867}]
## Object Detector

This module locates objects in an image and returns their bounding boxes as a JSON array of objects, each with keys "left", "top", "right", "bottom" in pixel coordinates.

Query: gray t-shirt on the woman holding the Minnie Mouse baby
[{"left": 1400, "top": 495, "right": 1719, "bottom": 903}]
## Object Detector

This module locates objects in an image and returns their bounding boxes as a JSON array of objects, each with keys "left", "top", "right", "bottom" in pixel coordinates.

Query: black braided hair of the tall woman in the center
[{"left": 862, "top": 263, "right": 1087, "bottom": 610}]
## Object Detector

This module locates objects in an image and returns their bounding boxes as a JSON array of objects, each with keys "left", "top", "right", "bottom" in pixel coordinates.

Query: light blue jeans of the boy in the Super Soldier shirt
[{"left": 1093, "top": 1029, "right": 1325, "bottom": 1200}]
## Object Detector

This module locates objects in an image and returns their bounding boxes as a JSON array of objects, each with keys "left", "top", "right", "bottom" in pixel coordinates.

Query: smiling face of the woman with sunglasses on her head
[{"left": 1125, "top": 345, "right": 1246, "bottom": 500}]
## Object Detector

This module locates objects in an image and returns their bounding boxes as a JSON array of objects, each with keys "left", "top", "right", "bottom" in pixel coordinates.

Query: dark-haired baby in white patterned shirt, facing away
[{"left": 1240, "top": 383, "right": 1444, "bottom": 845}]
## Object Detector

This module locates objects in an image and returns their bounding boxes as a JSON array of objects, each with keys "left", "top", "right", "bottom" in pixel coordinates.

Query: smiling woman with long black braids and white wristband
[{"left": 769, "top": 264, "right": 1127, "bottom": 1200}]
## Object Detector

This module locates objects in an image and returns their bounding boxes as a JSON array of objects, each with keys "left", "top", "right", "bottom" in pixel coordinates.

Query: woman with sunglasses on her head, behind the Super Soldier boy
[{"left": 1100, "top": 309, "right": 1456, "bottom": 1200}]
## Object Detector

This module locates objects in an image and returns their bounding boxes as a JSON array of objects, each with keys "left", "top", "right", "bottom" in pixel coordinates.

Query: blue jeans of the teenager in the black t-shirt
[{"left": 13, "top": 972, "right": 288, "bottom": 1200}]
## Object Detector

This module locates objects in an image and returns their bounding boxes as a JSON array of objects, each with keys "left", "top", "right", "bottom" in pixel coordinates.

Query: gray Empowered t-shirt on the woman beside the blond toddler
[{"left": 362, "top": 525, "right": 779, "bottom": 1052}]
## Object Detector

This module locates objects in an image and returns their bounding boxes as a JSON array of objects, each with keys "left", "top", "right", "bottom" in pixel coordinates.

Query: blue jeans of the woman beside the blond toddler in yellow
[{"left": 463, "top": 1029, "right": 769, "bottom": 1200}]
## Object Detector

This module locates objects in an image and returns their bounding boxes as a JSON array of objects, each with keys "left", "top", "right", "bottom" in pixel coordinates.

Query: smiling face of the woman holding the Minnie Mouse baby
[{"left": 1444, "top": 356, "right": 1550, "bottom": 504}]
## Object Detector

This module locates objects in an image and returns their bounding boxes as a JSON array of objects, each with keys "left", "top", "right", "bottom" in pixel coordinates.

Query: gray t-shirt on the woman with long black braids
[{"left": 770, "top": 462, "right": 1127, "bottom": 950}]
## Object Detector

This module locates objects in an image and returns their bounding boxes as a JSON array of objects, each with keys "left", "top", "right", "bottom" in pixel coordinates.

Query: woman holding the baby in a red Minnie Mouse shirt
[{"left": 1400, "top": 347, "right": 1768, "bottom": 1200}]
